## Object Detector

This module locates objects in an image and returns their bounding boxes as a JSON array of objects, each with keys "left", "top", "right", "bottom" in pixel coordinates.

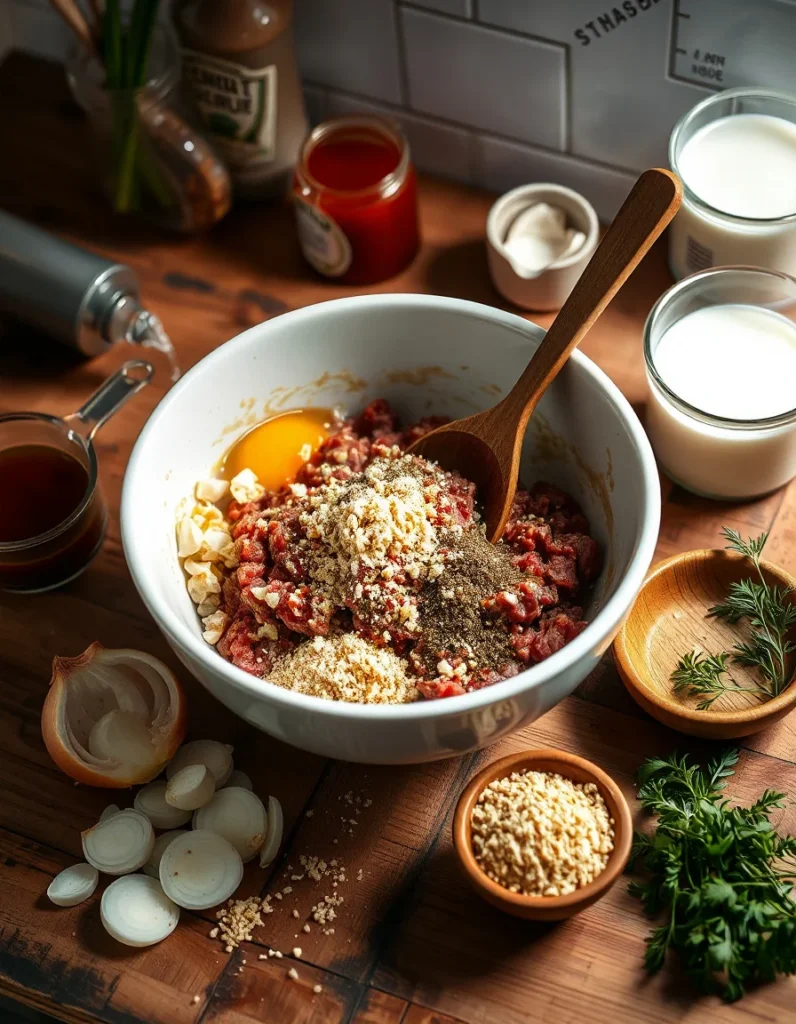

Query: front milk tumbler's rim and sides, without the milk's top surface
[{"left": 643, "top": 266, "right": 796, "bottom": 500}]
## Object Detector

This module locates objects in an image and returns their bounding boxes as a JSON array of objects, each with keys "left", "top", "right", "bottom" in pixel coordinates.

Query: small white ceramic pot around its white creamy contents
[{"left": 487, "top": 183, "right": 599, "bottom": 311}]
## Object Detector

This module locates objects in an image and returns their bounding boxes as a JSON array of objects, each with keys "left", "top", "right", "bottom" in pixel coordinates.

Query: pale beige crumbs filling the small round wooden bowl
[{"left": 471, "top": 771, "right": 614, "bottom": 896}]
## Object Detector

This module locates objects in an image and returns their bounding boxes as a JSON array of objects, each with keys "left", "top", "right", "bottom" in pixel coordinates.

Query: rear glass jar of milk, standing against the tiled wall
[{"left": 669, "top": 89, "right": 796, "bottom": 279}]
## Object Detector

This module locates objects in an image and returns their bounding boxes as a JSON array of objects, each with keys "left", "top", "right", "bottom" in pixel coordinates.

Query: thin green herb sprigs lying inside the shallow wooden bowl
[{"left": 671, "top": 526, "right": 796, "bottom": 711}]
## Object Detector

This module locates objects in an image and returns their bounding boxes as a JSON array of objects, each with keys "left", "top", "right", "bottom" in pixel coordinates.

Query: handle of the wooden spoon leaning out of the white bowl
[{"left": 500, "top": 168, "right": 682, "bottom": 430}]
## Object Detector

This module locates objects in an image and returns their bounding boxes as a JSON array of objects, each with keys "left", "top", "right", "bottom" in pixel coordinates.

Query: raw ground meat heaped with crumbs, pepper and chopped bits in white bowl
[{"left": 177, "top": 399, "right": 601, "bottom": 703}]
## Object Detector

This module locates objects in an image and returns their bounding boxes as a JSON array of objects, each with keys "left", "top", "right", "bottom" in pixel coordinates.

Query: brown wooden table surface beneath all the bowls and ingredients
[{"left": 0, "top": 56, "right": 796, "bottom": 1024}]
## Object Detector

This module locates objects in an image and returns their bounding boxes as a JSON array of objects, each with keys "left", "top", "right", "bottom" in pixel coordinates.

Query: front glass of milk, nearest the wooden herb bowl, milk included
[{"left": 643, "top": 266, "right": 796, "bottom": 500}]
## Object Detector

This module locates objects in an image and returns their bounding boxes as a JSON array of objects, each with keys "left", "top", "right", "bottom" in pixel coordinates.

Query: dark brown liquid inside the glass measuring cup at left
[{"left": 0, "top": 444, "right": 88, "bottom": 543}]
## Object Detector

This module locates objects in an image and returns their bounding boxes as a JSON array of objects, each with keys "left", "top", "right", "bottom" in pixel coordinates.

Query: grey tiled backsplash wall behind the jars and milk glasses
[{"left": 6, "top": 0, "right": 796, "bottom": 218}]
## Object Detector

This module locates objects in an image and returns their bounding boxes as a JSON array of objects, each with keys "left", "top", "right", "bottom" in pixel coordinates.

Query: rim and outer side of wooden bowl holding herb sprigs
[{"left": 614, "top": 548, "right": 796, "bottom": 725}]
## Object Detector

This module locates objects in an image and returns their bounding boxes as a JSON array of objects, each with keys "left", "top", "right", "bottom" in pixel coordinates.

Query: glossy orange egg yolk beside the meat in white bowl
[{"left": 222, "top": 409, "right": 333, "bottom": 490}]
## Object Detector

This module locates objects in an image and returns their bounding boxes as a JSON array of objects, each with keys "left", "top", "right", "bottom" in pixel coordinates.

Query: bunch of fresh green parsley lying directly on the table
[{"left": 630, "top": 751, "right": 796, "bottom": 1002}]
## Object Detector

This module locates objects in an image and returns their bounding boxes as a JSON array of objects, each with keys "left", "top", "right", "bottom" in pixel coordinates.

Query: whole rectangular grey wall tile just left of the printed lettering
[{"left": 401, "top": 7, "right": 564, "bottom": 150}]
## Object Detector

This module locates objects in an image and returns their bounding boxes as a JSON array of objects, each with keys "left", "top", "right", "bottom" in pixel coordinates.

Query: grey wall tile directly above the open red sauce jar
[{"left": 295, "top": 0, "right": 403, "bottom": 103}]
